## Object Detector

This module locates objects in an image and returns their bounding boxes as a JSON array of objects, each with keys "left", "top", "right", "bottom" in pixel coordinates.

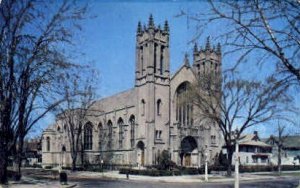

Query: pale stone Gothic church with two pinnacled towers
[{"left": 42, "top": 16, "right": 223, "bottom": 167}]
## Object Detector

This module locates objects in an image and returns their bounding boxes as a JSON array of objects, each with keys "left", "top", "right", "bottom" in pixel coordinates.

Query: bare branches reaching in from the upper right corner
[{"left": 179, "top": 0, "right": 300, "bottom": 85}]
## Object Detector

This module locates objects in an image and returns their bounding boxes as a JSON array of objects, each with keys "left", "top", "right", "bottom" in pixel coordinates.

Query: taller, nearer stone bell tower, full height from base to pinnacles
[{"left": 135, "top": 15, "right": 170, "bottom": 165}]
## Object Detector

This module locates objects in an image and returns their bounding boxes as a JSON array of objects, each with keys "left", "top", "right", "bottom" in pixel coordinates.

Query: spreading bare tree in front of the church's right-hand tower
[{"left": 187, "top": 73, "right": 290, "bottom": 176}]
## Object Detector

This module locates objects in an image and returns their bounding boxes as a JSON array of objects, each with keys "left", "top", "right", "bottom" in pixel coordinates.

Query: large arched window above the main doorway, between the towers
[{"left": 176, "top": 82, "right": 193, "bottom": 126}]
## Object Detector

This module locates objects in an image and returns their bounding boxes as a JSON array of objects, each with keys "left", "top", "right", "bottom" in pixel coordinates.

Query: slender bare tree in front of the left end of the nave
[{"left": 58, "top": 76, "right": 98, "bottom": 171}]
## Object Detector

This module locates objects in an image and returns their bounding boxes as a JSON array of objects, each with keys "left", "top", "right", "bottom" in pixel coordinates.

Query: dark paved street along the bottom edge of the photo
[{"left": 76, "top": 178, "right": 299, "bottom": 188}]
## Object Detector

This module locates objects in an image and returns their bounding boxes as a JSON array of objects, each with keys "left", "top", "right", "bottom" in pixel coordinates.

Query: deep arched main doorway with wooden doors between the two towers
[{"left": 180, "top": 136, "right": 198, "bottom": 166}]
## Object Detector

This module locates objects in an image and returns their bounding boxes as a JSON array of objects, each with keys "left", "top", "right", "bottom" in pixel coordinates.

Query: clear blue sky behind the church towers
[{"left": 33, "top": 0, "right": 299, "bottom": 136}]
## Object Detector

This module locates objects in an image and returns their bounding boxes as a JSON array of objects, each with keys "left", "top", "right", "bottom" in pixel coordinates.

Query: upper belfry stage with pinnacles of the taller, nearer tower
[{"left": 135, "top": 15, "right": 170, "bottom": 86}]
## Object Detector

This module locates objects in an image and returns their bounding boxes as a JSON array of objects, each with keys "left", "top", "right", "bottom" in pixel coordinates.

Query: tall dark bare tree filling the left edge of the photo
[{"left": 0, "top": 0, "right": 86, "bottom": 184}]
